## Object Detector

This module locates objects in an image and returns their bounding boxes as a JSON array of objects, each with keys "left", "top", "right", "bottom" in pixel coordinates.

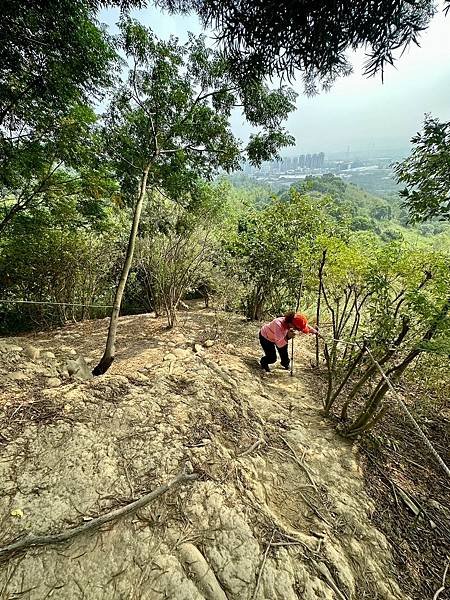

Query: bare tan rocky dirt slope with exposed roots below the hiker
[{"left": 0, "top": 310, "right": 407, "bottom": 600}]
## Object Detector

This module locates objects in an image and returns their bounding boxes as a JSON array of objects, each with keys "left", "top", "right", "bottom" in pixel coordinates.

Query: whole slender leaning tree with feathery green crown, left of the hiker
[{"left": 93, "top": 18, "right": 295, "bottom": 375}]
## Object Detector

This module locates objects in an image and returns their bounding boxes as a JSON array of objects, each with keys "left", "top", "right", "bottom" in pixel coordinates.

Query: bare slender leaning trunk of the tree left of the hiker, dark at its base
[{"left": 92, "top": 165, "right": 150, "bottom": 375}]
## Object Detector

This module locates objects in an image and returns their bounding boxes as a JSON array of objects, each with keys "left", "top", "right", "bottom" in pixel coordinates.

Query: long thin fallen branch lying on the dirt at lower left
[{"left": 0, "top": 472, "right": 198, "bottom": 557}]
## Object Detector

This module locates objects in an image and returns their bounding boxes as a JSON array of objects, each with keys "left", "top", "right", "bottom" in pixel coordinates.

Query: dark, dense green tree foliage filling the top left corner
[{"left": 0, "top": 0, "right": 116, "bottom": 135}]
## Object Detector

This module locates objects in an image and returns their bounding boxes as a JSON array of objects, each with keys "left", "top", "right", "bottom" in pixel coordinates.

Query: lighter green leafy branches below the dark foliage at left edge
[{"left": 0, "top": 105, "right": 117, "bottom": 234}]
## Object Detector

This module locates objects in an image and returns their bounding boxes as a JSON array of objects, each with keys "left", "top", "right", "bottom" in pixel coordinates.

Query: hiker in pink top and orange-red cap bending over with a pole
[{"left": 259, "top": 311, "right": 319, "bottom": 373}]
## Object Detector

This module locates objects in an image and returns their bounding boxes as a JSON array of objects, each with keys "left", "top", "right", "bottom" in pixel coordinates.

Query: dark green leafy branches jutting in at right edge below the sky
[{"left": 395, "top": 116, "right": 450, "bottom": 222}]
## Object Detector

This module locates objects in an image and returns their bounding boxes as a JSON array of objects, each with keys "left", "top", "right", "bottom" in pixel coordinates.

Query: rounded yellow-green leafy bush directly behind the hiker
[{"left": 223, "top": 190, "right": 345, "bottom": 318}]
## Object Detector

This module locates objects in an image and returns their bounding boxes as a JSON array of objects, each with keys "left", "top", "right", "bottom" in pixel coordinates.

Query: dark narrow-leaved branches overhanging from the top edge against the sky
[{"left": 156, "top": 0, "right": 448, "bottom": 88}]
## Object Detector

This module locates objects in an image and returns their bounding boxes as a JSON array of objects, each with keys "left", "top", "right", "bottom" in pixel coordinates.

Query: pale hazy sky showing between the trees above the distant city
[{"left": 100, "top": 8, "right": 450, "bottom": 156}]
